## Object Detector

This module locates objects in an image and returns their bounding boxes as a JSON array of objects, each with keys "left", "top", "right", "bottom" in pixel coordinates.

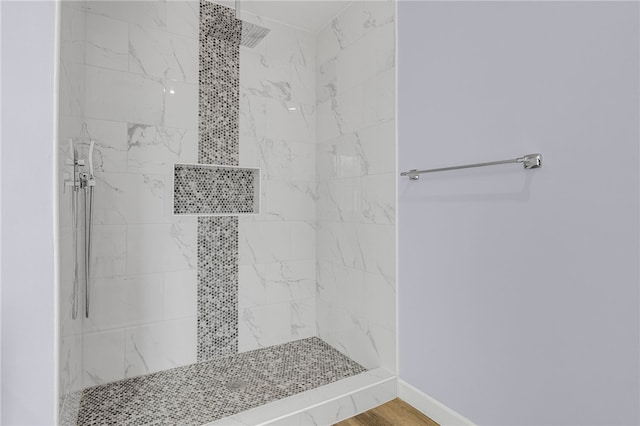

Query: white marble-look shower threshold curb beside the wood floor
[{"left": 206, "top": 368, "right": 398, "bottom": 426}]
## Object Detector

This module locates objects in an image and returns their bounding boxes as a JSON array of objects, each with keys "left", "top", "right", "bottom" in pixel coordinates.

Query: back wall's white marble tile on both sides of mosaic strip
[{"left": 61, "top": 1, "right": 316, "bottom": 388}]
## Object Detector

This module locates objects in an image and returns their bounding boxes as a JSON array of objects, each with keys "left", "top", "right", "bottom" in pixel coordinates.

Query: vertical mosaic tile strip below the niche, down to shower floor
[{"left": 197, "top": 216, "right": 238, "bottom": 361}]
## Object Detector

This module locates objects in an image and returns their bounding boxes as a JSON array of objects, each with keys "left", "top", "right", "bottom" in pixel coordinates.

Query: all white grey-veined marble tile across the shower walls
[{"left": 60, "top": 1, "right": 395, "bottom": 408}]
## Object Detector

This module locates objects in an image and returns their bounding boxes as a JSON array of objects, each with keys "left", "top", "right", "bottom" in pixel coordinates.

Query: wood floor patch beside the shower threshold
[{"left": 335, "top": 398, "right": 439, "bottom": 426}]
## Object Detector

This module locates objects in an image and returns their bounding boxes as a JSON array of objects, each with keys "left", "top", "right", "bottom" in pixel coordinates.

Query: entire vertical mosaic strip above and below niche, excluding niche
[{"left": 197, "top": 0, "right": 242, "bottom": 361}]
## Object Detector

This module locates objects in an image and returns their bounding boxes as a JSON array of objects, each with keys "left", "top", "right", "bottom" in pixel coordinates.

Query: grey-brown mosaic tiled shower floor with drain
[{"left": 77, "top": 337, "right": 365, "bottom": 425}]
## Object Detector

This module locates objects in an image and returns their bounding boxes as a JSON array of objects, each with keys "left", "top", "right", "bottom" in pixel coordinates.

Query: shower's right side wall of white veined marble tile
[{"left": 316, "top": 1, "right": 396, "bottom": 371}]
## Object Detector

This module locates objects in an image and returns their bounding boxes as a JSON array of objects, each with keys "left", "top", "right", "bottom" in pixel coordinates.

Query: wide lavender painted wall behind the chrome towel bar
[{"left": 398, "top": 1, "right": 640, "bottom": 425}]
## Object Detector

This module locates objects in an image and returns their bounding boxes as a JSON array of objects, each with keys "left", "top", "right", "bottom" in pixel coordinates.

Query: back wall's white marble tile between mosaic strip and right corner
[{"left": 238, "top": 12, "right": 317, "bottom": 352}]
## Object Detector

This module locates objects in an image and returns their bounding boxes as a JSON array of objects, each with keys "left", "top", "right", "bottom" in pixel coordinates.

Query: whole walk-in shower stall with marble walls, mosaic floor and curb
[{"left": 58, "top": 0, "right": 397, "bottom": 425}]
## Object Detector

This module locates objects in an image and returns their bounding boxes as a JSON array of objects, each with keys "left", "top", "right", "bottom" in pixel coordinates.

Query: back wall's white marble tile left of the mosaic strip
[{"left": 82, "top": 1, "right": 199, "bottom": 387}]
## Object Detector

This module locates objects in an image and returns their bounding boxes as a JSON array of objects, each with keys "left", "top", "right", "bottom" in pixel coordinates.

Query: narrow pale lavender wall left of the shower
[{"left": 0, "top": 1, "right": 56, "bottom": 425}]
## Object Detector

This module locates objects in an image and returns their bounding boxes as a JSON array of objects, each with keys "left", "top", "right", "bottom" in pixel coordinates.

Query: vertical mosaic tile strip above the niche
[{"left": 198, "top": 0, "right": 242, "bottom": 166}]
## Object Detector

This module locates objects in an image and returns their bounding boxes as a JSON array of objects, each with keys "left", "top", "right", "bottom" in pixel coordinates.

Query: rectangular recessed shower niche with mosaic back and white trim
[{"left": 173, "top": 164, "right": 258, "bottom": 214}]
